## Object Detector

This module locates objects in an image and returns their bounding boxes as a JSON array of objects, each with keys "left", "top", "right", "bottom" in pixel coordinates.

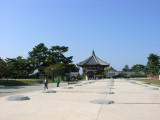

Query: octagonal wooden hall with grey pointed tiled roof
[{"left": 77, "top": 51, "right": 109, "bottom": 79}]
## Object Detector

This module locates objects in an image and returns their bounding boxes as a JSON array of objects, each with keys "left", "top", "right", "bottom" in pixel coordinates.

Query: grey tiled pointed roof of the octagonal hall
[{"left": 77, "top": 51, "right": 109, "bottom": 66}]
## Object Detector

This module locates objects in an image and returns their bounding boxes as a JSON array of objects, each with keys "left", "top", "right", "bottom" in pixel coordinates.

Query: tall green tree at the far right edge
[{"left": 147, "top": 53, "right": 160, "bottom": 76}]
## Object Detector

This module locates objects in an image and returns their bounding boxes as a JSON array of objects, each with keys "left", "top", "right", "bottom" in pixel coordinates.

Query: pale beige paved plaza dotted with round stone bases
[{"left": 0, "top": 79, "right": 160, "bottom": 120}]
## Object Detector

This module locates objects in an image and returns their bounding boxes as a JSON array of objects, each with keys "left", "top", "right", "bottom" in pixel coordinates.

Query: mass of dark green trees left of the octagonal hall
[{"left": 0, "top": 43, "right": 79, "bottom": 78}]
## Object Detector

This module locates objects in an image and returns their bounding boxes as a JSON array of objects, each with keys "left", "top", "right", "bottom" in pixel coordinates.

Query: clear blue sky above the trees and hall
[{"left": 0, "top": 0, "right": 160, "bottom": 70}]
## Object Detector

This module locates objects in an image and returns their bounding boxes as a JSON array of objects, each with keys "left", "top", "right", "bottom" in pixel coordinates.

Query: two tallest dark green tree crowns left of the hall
[{"left": 29, "top": 43, "right": 72, "bottom": 74}]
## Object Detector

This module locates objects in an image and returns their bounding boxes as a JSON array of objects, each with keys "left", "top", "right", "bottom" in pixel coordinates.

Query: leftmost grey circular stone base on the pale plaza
[{"left": 7, "top": 95, "right": 30, "bottom": 101}]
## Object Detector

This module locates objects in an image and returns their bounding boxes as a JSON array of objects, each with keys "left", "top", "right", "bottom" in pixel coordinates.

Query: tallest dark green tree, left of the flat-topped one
[{"left": 28, "top": 43, "right": 48, "bottom": 74}]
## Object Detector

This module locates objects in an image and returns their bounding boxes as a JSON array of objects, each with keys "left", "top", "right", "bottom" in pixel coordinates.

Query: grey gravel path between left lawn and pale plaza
[{"left": 0, "top": 83, "right": 68, "bottom": 97}]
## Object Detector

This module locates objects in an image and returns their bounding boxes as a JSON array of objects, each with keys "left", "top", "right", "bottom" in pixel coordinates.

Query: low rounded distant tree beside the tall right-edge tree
[{"left": 131, "top": 64, "right": 146, "bottom": 74}]
